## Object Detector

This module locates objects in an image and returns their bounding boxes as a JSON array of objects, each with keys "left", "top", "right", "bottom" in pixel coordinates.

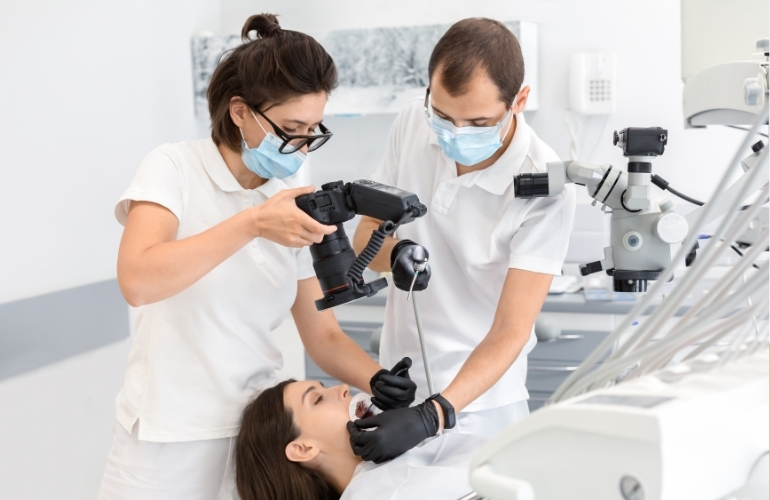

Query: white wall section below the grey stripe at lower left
[{"left": 0, "top": 339, "right": 130, "bottom": 500}]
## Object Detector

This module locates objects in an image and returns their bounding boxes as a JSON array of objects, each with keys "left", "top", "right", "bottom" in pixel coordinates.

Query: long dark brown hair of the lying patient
[{"left": 235, "top": 380, "right": 340, "bottom": 500}]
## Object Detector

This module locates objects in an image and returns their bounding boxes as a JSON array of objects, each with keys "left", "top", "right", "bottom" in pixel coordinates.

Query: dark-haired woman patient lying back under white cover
[{"left": 235, "top": 380, "right": 485, "bottom": 500}]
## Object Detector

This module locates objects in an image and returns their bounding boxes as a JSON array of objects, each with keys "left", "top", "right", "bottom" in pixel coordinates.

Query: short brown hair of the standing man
[{"left": 428, "top": 17, "right": 524, "bottom": 105}]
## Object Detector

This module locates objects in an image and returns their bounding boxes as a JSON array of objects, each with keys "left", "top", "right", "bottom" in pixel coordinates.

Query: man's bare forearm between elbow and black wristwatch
[{"left": 441, "top": 327, "right": 532, "bottom": 412}]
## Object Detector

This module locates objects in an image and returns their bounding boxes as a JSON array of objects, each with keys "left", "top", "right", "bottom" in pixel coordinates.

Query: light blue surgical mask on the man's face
[{"left": 426, "top": 110, "right": 513, "bottom": 165}]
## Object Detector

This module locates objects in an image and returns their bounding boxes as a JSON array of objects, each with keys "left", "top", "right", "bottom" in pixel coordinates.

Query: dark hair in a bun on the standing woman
[{"left": 206, "top": 14, "right": 337, "bottom": 151}]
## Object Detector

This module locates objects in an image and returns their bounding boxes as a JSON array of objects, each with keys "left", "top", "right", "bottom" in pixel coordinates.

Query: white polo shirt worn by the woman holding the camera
[{"left": 115, "top": 139, "right": 314, "bottom": 442}]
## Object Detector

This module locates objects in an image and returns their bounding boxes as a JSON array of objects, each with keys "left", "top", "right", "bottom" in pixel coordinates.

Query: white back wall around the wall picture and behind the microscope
[{"left": 222, "top": 0, "right": 752, "bottom": 209}]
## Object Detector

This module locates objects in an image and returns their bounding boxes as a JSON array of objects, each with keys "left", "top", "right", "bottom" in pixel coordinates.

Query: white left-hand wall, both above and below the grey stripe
[{"left": 0, "top": 0, "right": 219, "bottom": 500}]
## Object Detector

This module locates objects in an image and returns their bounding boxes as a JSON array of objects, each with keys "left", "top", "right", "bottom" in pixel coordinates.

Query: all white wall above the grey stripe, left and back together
[{"left": 0, "top": 0, "right": 752, "bottom": 303}]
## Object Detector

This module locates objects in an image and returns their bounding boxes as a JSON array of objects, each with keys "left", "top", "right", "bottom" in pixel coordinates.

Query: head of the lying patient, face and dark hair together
[{"left": 235, "top": 380, "right": 352, "bottom": 500}]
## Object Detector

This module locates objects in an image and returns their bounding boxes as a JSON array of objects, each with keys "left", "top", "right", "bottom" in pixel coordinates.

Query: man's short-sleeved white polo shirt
[{"left": 372, "top": 99, "right": 575, "bottom": 411}]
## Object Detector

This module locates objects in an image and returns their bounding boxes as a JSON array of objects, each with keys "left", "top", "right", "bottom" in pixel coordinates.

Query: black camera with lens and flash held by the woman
[{"left": 296, "top": 180, "right": 427, "bottom": 311}]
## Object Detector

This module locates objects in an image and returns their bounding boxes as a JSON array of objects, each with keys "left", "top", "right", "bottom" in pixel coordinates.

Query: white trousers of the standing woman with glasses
[{"left": 98, "top": 422, "right": 237, "bottom": 500}]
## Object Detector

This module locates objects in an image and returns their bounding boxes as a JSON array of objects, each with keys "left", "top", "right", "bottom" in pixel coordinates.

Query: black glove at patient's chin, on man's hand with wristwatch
[{"left": 348, "top": 401, "right": 438, "bottom": 464}]
